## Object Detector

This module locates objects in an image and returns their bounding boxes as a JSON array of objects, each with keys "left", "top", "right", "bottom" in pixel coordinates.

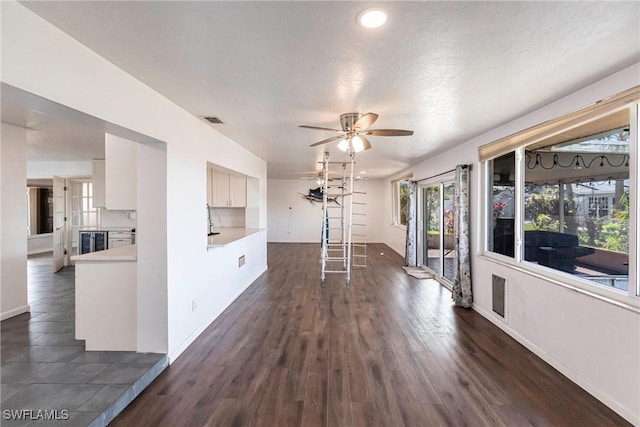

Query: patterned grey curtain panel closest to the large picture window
[{"left": 452, "top": 165, "right": 473, "bottom": 308}]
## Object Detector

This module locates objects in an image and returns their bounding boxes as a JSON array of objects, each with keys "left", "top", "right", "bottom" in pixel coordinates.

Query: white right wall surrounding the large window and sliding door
[{"left": 385, "top": 64, "right": 640, "bottom": 425}]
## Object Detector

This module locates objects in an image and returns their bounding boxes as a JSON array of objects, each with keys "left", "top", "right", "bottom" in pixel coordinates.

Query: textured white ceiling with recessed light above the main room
[{"left": 13, "top": 1, "right": 640, "bottom": 178}]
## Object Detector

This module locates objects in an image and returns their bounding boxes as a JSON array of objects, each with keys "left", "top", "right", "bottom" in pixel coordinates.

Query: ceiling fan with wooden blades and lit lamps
[{"left": 300, "top": 113, "right": 413, "bottom": 153}]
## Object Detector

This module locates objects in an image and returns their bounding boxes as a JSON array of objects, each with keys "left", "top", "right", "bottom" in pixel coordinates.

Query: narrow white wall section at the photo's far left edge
[{"left": 0, "top": 123, "right": 29, "bottom": 319}]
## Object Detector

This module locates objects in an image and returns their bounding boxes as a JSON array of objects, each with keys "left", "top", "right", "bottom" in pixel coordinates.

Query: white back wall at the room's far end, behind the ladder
[{"left": 267, "top": 179, "right": 385, "bottom": 243}]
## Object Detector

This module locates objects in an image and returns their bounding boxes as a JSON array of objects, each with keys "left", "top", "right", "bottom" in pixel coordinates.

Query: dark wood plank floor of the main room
[{"left": 113, "top": 244, "right": 627, "bottom": 427}]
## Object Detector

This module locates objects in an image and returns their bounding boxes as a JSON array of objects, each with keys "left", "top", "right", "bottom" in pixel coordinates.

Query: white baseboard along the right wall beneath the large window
[{"left": 472, "top": 304, "right": 640, "bottom": 426}]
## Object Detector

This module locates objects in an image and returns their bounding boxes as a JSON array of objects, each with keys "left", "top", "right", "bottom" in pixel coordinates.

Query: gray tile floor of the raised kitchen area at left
[{"left": 0, "top": 254, "right": 167, "bottom": 426}]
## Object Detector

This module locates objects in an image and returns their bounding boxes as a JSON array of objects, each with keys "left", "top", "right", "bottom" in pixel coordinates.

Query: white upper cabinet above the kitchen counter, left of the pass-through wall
[{"left": 104, "top": 134, "right": 138, "bottom": 210}]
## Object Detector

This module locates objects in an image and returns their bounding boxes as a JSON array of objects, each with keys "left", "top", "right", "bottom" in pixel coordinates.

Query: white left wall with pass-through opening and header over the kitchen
[{"left": 0, "top": 2, "right": 266, "bottom": 360}]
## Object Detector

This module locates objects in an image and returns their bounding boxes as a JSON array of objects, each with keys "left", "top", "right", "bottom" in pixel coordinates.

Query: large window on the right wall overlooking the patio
[{"left": 480, "top": 89, "right": 640, "bottom": 295}]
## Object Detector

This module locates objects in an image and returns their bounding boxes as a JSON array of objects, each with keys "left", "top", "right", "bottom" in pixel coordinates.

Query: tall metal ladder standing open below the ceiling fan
[{"left": 320, "top": 152, "right": 366, "bottom": 286}]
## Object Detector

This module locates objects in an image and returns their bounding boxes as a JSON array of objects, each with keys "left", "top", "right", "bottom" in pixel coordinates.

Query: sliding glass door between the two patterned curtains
[{"left": 418, "top": 177, "right": 455, "bottom": 283}]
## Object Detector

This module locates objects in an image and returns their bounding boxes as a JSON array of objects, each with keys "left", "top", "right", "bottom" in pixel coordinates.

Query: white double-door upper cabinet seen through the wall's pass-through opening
[{"left": 207, "top": 168, "right": 247, "bottom": 208}]
